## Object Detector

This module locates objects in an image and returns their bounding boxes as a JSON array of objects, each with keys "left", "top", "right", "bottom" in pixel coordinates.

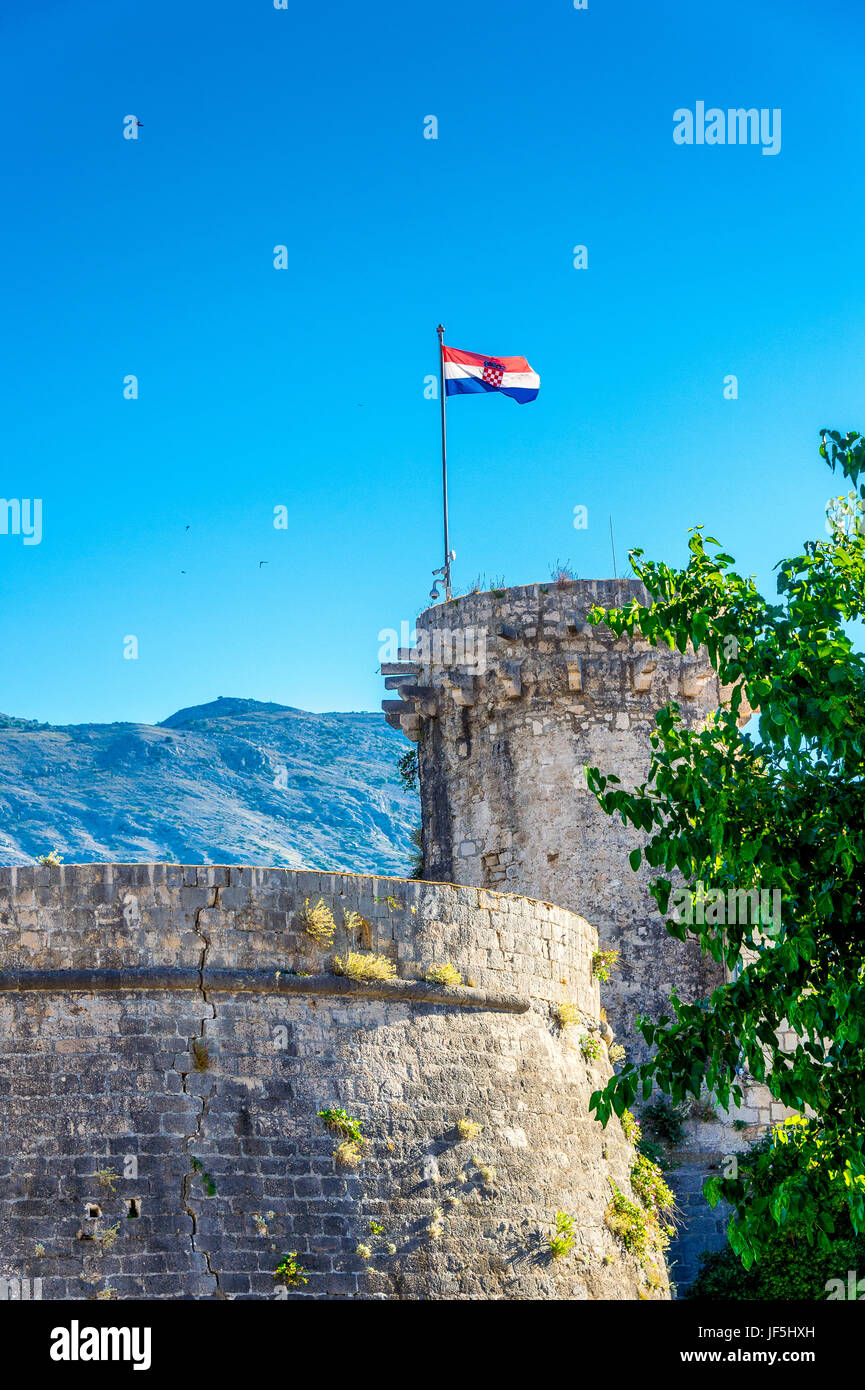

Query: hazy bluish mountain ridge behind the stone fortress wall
[{"left": 0, "top": 696, "right": 420, "bottom": 874}]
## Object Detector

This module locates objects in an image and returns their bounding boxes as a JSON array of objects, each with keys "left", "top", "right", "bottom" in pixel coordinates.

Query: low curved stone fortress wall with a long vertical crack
[{"left": 0, "top": 865, "right": 666, "bottom": 1298}]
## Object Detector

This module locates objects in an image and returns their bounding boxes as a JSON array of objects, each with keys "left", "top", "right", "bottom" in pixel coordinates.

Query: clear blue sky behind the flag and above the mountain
[{"left": 0, "top": 0, "right": 865, "bottom": 723}]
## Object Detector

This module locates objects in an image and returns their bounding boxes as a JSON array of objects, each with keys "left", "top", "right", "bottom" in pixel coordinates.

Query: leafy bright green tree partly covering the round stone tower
[{"left": 588, "top": 431, "right": 865, "bottom": 1268}]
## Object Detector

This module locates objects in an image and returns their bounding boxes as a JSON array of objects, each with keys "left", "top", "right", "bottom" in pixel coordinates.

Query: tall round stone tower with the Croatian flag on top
[{"left": 382, "top": 580, "right": 769, "bottom": 1284}]
